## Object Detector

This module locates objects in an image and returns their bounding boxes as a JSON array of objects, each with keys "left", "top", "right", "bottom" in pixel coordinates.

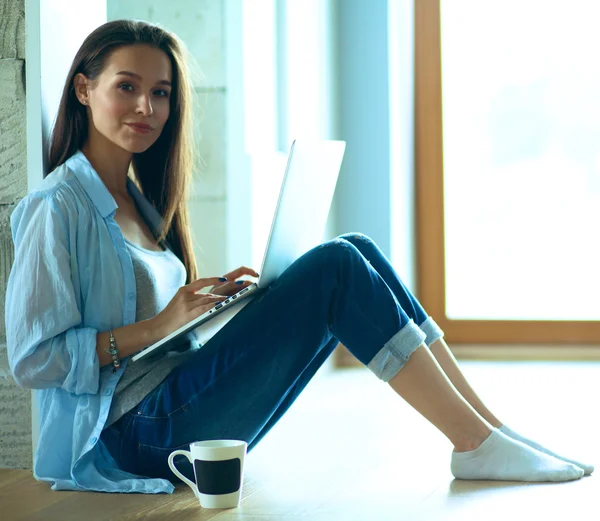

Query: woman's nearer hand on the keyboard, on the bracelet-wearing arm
[{"left": 151, "top": 277, "right": 227, "bottom": 341}]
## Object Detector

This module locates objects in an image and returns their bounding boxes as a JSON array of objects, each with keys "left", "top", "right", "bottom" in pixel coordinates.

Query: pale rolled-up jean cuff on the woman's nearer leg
[{"left": 367, "top": 320, "right": 426, "bottom": 382}]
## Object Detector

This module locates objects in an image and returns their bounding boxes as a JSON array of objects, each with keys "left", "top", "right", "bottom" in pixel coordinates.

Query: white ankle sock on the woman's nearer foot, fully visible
[{"left": 450, "top": 429, "right": 583, "bottom": 481}]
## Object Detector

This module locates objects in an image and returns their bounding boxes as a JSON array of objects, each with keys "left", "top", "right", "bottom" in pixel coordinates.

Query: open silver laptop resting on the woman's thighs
[{"left": 131, "top": 140, "right": 346, "bottom": 362}]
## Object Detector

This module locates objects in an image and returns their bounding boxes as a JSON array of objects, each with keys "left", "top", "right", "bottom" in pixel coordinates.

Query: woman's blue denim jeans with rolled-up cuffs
[{"left": 101, "top": 234, "right": 443, "bottom": 482}]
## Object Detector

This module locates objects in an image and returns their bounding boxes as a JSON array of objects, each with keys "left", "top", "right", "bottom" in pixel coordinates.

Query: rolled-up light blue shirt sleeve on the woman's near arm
[{"left": 5, "top": 192, "right": 100, "bottom": 394}]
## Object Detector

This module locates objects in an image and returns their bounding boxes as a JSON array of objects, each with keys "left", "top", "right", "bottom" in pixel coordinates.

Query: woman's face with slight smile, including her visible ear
[{"left": 75, "top": 45, "right": 172, "bottom": 153}]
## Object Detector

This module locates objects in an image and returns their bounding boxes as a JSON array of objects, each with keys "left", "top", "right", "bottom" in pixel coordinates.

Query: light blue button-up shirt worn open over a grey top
[{"left": 6, "top": 151, "right": 183, "bottom": 493}]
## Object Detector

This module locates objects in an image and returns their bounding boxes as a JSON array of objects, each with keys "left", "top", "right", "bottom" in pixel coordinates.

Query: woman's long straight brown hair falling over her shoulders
[{"left": 48, "top": 20, "right": 198, "bottom": 283}]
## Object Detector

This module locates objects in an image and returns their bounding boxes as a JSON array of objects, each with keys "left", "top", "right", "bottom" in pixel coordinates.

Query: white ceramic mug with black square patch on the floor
[{"left": 168, "top": 440, "right": 248, "bottom": 508}]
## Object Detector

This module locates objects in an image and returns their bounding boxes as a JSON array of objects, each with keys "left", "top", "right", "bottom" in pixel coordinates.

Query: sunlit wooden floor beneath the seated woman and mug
[{"left": 0, "top": 361, "right": 600, "bottom": 521}]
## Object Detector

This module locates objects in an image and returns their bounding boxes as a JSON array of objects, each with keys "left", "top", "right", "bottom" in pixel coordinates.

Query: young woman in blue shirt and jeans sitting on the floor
[{"left": 6, "top": 21, "right": 593, "bottom": 493}]
